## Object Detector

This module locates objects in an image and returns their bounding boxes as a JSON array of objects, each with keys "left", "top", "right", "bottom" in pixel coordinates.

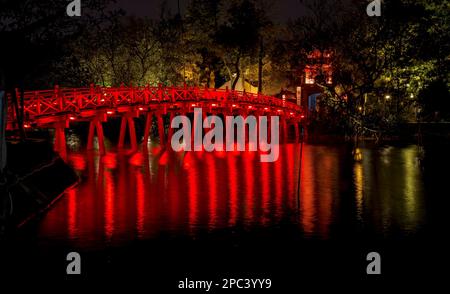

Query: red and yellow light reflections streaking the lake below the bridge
[{"left": 39, "top": 144, "right": 426, "bottom": 248}]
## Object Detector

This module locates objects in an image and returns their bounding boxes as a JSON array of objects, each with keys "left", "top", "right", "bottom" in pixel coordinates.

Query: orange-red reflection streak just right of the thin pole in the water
[{"left": 300, "top": 146, "right": 316, "bottom": 234}]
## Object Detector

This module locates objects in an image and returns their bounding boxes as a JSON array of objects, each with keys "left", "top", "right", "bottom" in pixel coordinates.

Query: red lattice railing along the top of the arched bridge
[{"left": 9, "top": 86, "right": 302, "bottom": 126}]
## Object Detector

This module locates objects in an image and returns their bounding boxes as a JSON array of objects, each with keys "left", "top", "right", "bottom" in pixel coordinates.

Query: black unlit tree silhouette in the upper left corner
[{"left": 0, "top": 0, "right": 110, "bottom": 138}]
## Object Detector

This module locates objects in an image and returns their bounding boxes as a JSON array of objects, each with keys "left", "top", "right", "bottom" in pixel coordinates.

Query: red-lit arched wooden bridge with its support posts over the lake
[{"left": 8, "top": 86, "right": 304, "bottom": 154}]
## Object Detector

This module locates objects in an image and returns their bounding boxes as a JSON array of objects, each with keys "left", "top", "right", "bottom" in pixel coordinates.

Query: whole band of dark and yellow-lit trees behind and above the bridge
[{"left": 0, "top": 0, "right": 450, "bottom": 133}]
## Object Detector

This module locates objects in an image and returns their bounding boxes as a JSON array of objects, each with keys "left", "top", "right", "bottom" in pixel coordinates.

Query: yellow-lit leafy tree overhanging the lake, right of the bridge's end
[{"left": 294, "top": 0, "right": 449, "bottom": 134}]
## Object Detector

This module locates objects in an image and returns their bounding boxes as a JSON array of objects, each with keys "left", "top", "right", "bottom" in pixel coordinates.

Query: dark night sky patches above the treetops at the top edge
[{"left": 117, "top": 0, "right": 308, "bottom": 20}]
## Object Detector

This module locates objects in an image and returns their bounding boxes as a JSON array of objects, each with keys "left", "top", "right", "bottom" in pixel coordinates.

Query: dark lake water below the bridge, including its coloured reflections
[{"left": 1, "top": 139, "right": 450, "bottom": 284}]
